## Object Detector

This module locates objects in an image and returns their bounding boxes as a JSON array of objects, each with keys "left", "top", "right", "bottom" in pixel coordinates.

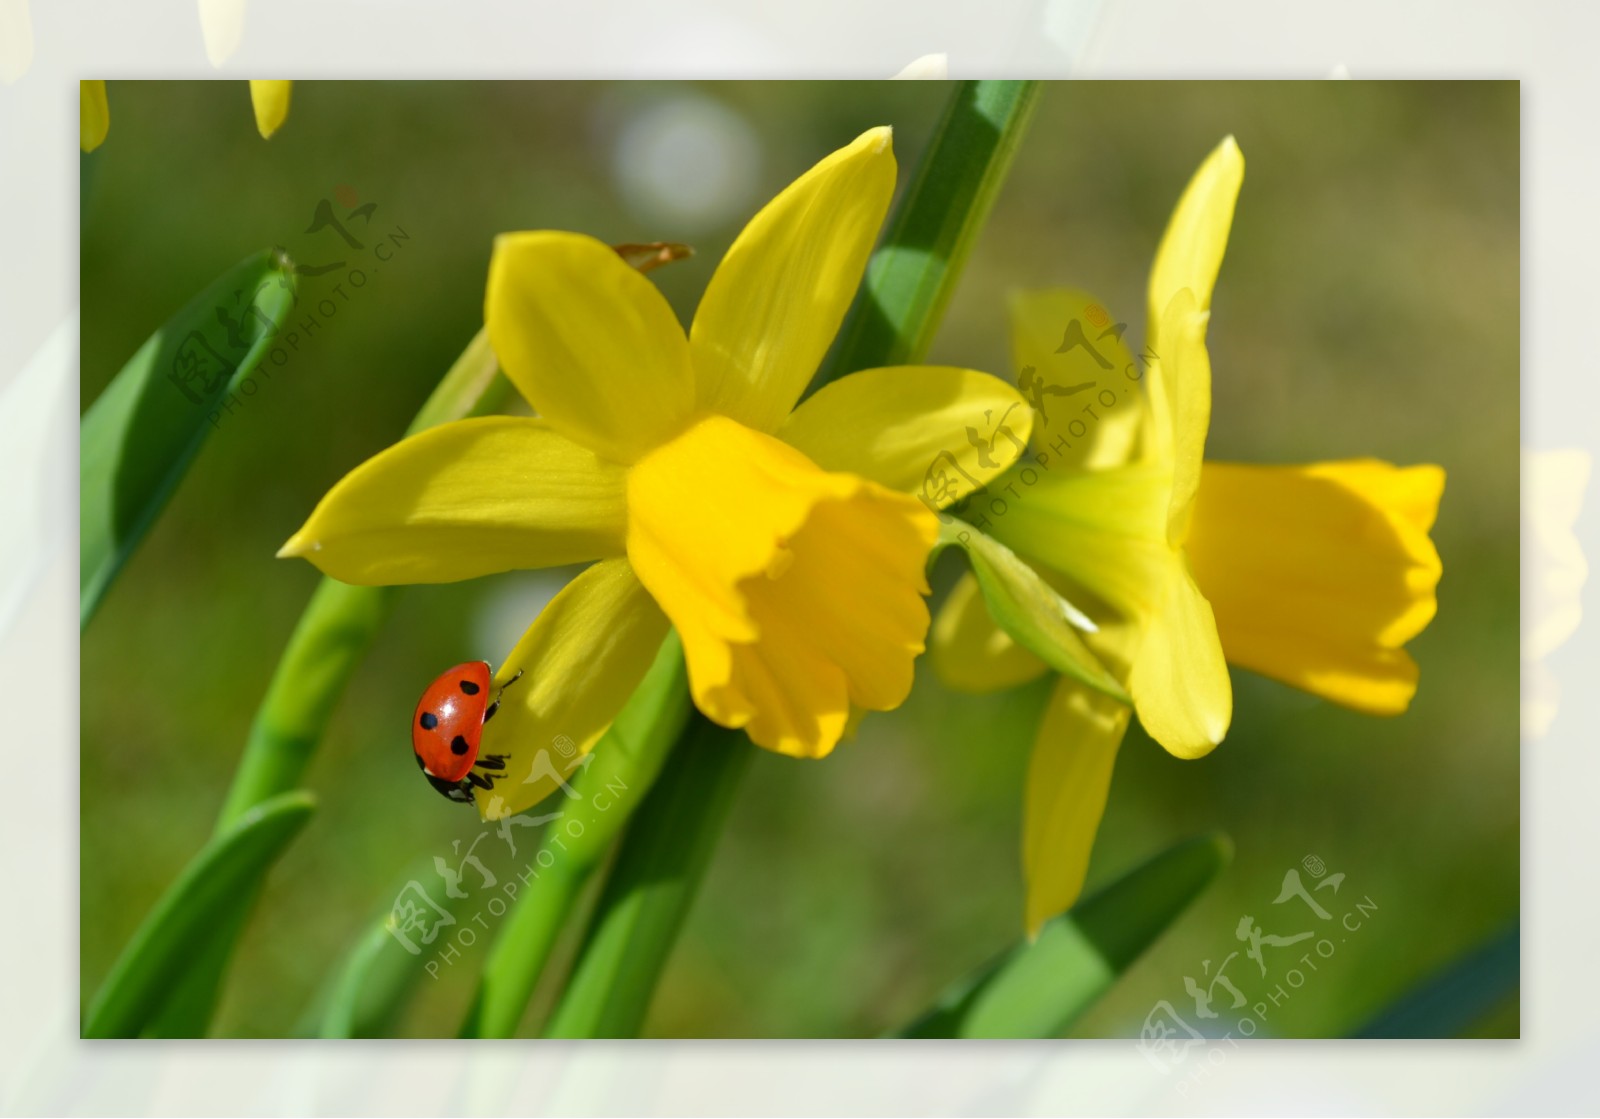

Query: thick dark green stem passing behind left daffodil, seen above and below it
[{"left": 547, "top": 82, "right": 1037, "bottom": 1037}]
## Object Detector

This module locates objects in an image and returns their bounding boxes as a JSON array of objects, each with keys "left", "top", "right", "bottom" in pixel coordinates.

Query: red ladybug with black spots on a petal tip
[{"left": 411, "top": 661, "right": 522, "bottom": 804}]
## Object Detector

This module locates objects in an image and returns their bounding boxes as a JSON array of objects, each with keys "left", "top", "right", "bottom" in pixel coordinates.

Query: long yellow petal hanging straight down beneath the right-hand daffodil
[{"left": 1022, "top": 680, "right": 1128, "bottom": 937}]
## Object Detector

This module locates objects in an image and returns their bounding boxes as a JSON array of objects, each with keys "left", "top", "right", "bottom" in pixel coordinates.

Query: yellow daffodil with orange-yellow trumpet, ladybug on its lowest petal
[{"left": 280, "top": 128, "right": 1027, "bottom": 818}]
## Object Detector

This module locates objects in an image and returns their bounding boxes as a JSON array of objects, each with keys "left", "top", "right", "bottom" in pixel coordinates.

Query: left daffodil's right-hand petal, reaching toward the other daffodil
[{"left": 778, "top": 365, "right": 1032, "bottom": 509}]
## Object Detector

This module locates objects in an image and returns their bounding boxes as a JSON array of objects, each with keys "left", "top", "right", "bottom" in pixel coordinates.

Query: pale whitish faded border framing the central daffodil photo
[{"left": 0, "top": 0, "right": 1600, "bottom": 1114}]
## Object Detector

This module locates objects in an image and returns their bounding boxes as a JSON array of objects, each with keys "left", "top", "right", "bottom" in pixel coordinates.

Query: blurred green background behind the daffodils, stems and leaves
[{"left": 80, "top": 82, "right": 1520, "bottom": 1036}]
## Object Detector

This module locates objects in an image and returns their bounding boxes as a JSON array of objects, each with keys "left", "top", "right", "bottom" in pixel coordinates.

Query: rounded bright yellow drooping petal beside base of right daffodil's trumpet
[{"left": 1128, "top": 554, "right": 1234, "bottom": 757}]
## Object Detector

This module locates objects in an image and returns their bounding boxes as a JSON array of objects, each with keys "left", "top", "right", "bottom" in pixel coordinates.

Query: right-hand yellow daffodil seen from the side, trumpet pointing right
[{"left": 933, "top": 138, "right": 1445, "bottom": 932}]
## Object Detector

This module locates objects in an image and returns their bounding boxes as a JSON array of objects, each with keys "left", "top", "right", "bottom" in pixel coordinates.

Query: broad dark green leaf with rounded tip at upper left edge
[{"left": 78, "top": 251, "right": 294, "bottom": 626}]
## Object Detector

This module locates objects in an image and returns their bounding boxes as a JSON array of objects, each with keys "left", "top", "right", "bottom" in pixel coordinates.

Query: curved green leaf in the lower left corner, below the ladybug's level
[{"left": 83, "top": 792, "right": 315, "bottom": 1037}]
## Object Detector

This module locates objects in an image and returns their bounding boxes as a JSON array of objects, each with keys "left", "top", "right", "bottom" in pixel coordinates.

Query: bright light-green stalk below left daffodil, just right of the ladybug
[{"left": 461, "top": 632, "right": 691, "bottom": 1037}]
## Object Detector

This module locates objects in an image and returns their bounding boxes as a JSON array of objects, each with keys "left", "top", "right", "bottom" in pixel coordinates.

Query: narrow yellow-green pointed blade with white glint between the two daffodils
[{"left": 928, "top": 519, "right": 1133, "bottom": 706}]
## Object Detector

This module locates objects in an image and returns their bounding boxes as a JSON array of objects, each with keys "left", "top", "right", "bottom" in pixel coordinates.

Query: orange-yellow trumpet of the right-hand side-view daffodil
[{"left": 1186, "top": 459, "right": 1445, "bottom": 714}]
